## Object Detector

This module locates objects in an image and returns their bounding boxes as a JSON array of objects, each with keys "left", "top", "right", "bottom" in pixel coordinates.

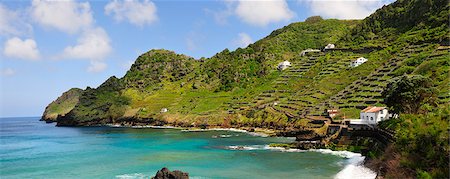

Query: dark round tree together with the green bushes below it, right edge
[{"left": 381, "top": 75, "right": 450, "bottom": 178}]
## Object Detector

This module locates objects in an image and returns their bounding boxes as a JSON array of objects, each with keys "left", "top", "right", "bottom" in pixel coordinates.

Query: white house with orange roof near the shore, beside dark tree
[{"left": 350, "top": 106, "right": 389, "bottom": 125}]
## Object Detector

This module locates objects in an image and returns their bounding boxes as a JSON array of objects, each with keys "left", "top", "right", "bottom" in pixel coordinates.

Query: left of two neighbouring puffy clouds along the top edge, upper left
[{"left": 31, "top": 0, "right": 94, "bottom": 33}]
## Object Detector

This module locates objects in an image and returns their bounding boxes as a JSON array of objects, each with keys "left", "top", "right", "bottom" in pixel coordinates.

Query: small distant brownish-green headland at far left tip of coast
[{"left": 41, "top": 88, "right": 83, "bottom": 122}]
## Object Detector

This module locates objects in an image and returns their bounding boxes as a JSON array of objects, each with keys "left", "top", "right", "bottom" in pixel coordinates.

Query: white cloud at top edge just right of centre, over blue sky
[{"left": 235, "top": 0, "right": 295, "bottom": 26}]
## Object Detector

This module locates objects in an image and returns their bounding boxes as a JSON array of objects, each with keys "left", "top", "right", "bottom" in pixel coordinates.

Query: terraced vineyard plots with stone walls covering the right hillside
[{"left": 224, "top": 40, "right": 449, "bottom": 127}]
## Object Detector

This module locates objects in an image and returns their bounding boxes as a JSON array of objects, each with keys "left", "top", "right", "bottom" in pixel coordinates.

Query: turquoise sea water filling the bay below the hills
[{"left": 0, "top": 117, "right": 364, "bottom": 179}]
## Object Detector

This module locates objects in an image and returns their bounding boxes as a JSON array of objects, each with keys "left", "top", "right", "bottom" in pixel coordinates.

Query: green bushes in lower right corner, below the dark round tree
[{"left": 382, "top": 108, "right": 450, "bottom": 178}]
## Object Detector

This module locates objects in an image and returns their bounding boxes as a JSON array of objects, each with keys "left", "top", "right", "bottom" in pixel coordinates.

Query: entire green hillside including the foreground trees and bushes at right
[{"left": 42, "top": 0, "right": 450, "bottom": 178}]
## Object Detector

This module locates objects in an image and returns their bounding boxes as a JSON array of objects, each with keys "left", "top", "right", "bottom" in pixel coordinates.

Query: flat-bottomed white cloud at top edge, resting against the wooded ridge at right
[{"left": 305, "top": 0, "right": 389, "bottom": 19}]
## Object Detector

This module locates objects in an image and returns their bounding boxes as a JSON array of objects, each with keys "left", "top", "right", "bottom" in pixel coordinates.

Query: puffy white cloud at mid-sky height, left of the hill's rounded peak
[{"left": 64, "top": 27, "right": 112, "bottom": 60}]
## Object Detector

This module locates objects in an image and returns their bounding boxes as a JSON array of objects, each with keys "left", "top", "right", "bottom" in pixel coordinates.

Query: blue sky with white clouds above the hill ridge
[{"left": 0, "top": 0, "right": 393, "bottom": 117}]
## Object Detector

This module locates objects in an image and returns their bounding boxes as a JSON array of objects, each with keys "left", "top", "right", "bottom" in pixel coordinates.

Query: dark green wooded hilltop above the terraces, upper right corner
[{"left": 343, "top": 0, "right": 450, "bottom": 46}]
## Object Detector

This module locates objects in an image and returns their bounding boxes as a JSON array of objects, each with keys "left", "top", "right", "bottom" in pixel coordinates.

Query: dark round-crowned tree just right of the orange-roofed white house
[{"left": 382, "top": 75, "right": 437, "bottom": 114}]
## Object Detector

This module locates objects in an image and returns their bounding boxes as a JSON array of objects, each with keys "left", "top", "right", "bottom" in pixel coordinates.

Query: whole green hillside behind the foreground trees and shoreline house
[{"left": 43, "top": 0, "right": 449, "bottom": 131}]
